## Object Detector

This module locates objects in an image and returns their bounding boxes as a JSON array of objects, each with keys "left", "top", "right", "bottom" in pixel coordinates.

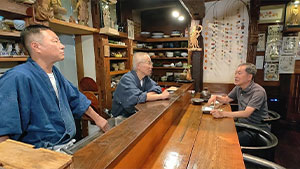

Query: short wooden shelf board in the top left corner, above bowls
[{"left": 0, "top": 0, "right": 32, "bottom": 18}]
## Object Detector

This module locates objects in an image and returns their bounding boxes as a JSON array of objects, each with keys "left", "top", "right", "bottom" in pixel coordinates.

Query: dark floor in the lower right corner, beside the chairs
[{"left": 272, "top": 120, "right": 300, "bottom": 169}]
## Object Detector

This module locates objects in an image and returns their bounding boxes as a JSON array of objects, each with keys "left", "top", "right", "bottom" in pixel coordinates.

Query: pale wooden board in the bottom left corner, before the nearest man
[{"left": 0, "top": 139, "right": 73, "bottom": 169}]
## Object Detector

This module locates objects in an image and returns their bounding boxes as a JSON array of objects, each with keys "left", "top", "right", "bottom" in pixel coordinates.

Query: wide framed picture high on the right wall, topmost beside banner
[{"left": 258, "top": 4, "right": 285, "bottom": 23}]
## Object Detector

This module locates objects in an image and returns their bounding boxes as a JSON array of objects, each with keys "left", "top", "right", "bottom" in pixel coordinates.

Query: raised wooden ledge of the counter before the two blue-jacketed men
[{"left": 73, "top": 84, "right": 192, "bottom": 169}]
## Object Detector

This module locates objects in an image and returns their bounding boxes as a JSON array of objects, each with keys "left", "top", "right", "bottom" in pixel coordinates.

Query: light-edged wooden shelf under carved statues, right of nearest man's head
[{"left": 49, "top": 19, "right": 99, "bottom": 35}]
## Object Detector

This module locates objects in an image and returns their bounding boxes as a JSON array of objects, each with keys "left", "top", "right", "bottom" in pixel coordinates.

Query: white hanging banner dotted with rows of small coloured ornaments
[{"left": 202, "top": 0, "right": 249, "bottom": 83}]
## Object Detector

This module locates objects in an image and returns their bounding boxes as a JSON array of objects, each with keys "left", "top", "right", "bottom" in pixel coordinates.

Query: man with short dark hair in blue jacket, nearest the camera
[{"left": 0, "top": 25, "right": 109, "bottom": 149}]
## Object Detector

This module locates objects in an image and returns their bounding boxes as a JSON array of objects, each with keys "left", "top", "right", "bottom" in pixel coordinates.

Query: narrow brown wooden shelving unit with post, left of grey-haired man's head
[{"left": 94, "top": 32, "right": 132, "bottom": 109}]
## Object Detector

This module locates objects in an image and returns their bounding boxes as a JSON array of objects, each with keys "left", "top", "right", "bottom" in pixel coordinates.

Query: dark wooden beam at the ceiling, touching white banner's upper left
[{"left": 179, "top": 0, "right": 205, "bottom": 20}]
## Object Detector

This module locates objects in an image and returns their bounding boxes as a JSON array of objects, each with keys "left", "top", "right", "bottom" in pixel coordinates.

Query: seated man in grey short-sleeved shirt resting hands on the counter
[{"left": 208, "top": 63, "right": 270, "bottom": 145}]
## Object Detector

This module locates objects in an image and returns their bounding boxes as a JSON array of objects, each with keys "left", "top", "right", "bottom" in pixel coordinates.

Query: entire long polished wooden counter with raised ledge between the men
[{"left": 73, "top": 84, "right": 245, "bottom": 169}]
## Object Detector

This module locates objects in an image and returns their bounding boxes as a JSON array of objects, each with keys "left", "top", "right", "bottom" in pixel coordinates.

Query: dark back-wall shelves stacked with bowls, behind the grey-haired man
[{"left": 133, "top": 37, "right": 191, "bottom": 86}]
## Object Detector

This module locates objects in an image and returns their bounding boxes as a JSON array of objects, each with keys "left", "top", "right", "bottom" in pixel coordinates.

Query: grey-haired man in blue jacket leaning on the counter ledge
[{"left": 111, "top": 52, "right": 169, "bottom": 117}]
